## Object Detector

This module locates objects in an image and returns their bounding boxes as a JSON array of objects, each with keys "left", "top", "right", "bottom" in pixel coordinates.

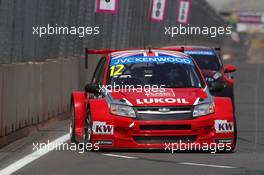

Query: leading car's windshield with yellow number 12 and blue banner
[{"left": 108, "top": 54, "right": 204, "bottom": 88}]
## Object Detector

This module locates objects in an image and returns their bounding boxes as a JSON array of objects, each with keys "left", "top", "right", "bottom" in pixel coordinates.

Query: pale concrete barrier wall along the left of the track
[{"left": 0, "top": 58, "right": 84, "bottom": 136}]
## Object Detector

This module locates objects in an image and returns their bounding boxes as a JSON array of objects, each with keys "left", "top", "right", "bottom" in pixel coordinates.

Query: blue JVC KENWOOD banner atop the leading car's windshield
[{"left": 110, "top": 56, "right": 193, "bottom": 66}]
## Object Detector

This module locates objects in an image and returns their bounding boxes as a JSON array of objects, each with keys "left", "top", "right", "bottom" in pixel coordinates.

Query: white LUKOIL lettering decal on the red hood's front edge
[{"left": 136, "top": 98, "right": 189, "bottom": 104}]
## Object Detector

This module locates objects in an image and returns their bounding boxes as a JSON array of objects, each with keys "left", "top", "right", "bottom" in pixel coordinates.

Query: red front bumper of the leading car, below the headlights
[{"left": 92, "top": 114, "right": 234, "bottom": 149}]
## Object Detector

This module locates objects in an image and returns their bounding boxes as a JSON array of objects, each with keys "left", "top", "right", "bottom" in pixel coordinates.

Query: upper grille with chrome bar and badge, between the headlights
[{"left": 135, "top": 106, "right": 193, "bottom": 120}]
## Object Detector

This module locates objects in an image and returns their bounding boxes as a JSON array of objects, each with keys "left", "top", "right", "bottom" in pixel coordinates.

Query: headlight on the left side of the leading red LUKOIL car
[{"left": 110, "top": 104, "right": 136, "bottom": 118}]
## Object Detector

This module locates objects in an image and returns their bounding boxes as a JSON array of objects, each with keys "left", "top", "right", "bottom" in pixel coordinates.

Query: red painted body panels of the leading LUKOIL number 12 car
[{"left": 72, "top": 49, "right": 234, "bottom": 149}]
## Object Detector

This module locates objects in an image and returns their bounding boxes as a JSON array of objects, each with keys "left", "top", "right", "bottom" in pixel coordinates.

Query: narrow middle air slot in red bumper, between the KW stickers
[{"left": 140, "top": 125, "right": 192, "bottom": 130}]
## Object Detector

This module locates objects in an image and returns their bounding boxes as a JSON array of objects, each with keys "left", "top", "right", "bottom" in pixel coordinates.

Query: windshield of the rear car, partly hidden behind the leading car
[{"left": 185, "top": 50, "right": 220, "bottom": 71}]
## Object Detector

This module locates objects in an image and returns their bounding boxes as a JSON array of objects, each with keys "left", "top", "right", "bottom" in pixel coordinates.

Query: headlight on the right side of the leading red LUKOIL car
[{"left": 193, "top": 103, "right": 214, "bottom": 117}]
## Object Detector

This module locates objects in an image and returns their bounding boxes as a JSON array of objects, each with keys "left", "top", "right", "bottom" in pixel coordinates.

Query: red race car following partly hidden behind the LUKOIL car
[{"left": 164, "top": 45, "right": 236, "bottom": 107}]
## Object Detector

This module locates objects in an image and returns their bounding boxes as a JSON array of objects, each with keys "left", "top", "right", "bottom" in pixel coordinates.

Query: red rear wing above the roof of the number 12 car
[{"left": 85, "top": 47, "right": 184, "bottom": 69}]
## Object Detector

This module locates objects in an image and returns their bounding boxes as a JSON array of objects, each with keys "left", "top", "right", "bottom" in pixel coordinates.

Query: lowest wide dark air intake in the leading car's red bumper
[{"left": 134, "top": 135, "right": 197, "bottom": 144}]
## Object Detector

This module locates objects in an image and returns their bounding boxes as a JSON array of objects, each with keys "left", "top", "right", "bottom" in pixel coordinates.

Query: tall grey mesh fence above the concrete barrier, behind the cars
[{"left": 0, "top": 0, "right": 224, "bottom": 64}]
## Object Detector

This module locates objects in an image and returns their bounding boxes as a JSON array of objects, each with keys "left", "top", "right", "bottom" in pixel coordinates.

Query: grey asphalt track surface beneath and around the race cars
[{"left": 0, "top": 63, "right": 264, "bottom": 175}]
